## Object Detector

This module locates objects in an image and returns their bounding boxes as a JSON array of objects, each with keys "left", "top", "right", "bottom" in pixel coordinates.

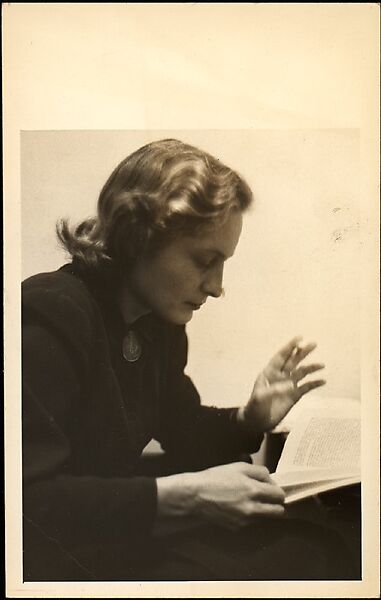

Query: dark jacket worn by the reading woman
[{"left": 22, "top": 264, "right": 262, "bottom": 579}]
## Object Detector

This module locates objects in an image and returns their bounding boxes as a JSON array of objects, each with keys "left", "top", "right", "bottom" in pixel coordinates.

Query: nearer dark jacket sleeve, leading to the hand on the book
[{"left": 23, "top": 278, "right": 156, "bottom": 564}]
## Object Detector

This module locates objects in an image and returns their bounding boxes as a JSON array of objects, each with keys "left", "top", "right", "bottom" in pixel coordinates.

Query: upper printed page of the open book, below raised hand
[{"left": 276, "top": 414, "right": 361, "bottom": 473}]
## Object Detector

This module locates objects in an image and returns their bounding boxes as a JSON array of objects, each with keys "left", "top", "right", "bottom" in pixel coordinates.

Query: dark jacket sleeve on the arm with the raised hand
[{"left": 154, "top": 327, "right": 263, "bottom": 470}]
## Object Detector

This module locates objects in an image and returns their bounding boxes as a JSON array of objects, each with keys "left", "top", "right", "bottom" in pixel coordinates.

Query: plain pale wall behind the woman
[{"left": 21, "top": 129, "right": 361, "bottom": 406}]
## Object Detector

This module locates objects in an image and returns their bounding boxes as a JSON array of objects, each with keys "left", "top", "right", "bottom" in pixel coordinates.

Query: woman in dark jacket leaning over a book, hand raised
[{"left": 23, "top": 140, "right": 354, "bottom": 580}]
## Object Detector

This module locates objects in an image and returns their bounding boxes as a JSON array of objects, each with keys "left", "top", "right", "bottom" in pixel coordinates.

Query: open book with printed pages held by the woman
[{"left": 266, "top": 398, "right": 361, "bottom": 504}]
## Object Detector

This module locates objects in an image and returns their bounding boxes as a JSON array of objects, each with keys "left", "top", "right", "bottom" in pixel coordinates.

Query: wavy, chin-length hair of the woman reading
[{"left": 56, "top": 139, "right": 252, "bottom": 269}]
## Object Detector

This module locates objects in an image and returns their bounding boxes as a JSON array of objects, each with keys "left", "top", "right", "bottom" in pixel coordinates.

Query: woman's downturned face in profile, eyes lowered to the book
[{"left": 127, "top": 210, "right": 242, "bottom": 324}]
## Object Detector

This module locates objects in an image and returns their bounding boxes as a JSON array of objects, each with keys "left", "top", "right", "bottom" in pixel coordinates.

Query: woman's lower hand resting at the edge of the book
[{"left": 157, "top": 462, "right": 285, "bottom": 530}]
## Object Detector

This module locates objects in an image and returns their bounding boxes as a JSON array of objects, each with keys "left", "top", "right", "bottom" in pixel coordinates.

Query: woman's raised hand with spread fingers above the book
[{"left": 238, "top": 337, "right": 325, "bottom": 432}]
